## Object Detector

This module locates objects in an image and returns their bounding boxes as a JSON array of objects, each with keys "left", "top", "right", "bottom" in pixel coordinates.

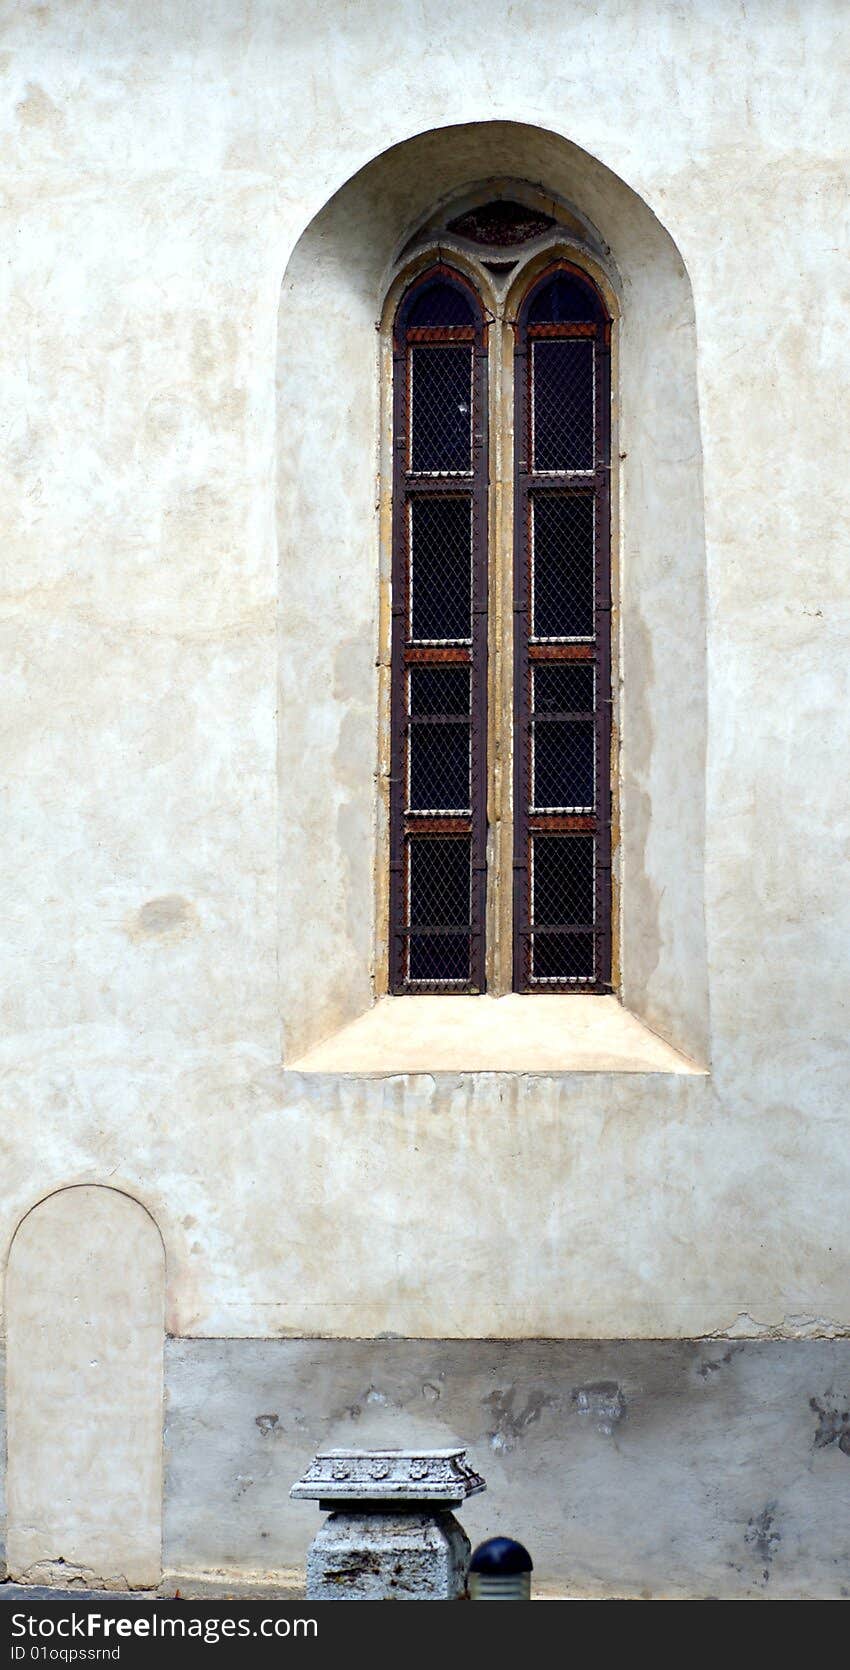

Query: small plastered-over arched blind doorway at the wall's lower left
[{"left": 5, "top": 1184, "right": 165, "bottom": 1588}]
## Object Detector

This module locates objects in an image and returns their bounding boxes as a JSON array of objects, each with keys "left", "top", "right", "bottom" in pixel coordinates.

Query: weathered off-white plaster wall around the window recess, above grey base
[{"left": 0, "top": 0, "right": 850, "bottom": 1336}]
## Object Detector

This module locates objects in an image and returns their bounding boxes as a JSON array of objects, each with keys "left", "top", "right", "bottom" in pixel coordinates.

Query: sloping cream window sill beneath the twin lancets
[{"left": 287, "top": 994, "right": 705, "bottom": 1077}]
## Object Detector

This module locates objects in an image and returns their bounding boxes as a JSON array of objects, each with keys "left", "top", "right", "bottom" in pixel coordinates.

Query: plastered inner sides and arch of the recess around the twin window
[{"left": 277, "top": 122, "right": 708, "bottom": 1062}]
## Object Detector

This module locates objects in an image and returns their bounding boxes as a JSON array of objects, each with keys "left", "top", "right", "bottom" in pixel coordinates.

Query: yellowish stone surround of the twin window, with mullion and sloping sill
[{"left": 289, "top": 205, "right": 706, "bottom": 1077}]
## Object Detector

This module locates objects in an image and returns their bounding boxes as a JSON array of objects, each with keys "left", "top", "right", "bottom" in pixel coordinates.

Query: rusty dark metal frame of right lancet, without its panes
[{"left": 513, "top": 259, "right": 611, "bottom": 992}]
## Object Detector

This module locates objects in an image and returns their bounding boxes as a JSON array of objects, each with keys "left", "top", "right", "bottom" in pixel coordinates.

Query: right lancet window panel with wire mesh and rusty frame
[{"left": 514, "top": 264, "right": 611, "bottom": 990}]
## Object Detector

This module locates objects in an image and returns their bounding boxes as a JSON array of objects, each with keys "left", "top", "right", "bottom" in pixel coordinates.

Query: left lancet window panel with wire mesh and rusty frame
[{"left": 389, "top": 264, "right": 488, "bottom": 992}]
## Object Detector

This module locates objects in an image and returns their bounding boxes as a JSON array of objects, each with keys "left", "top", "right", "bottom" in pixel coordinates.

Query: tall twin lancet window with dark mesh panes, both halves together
[{"left": 389, "top": 261, "right": 611, "bottom": 994}]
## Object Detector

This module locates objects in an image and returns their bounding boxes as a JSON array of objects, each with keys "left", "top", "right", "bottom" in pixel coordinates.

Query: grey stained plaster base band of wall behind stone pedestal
[{"left": 164, "top": 1339, "right": 850, "bottom": 1600}]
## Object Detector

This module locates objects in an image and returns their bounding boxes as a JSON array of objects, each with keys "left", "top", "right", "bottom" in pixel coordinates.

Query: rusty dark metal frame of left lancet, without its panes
[{"left": 389, "top": 261, "right": 488, "bottom": 994}]
